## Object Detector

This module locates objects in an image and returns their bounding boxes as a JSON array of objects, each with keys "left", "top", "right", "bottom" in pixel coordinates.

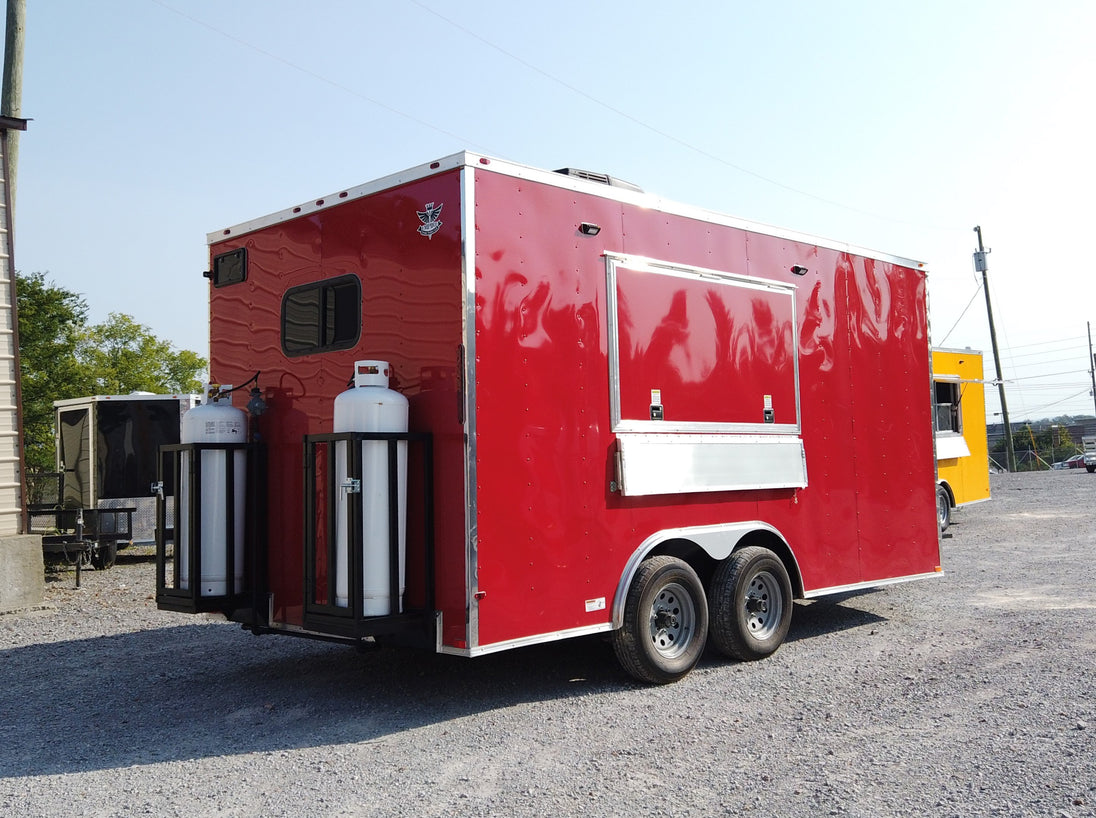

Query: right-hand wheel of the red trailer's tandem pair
[{"left": 708, "top": 546, "right": 794, "bottom": 661}]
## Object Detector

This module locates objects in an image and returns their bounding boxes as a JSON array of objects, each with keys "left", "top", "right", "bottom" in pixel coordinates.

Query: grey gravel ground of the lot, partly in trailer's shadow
[{"left": 0, "top": 470, "right": 1096, "bottom": 818}]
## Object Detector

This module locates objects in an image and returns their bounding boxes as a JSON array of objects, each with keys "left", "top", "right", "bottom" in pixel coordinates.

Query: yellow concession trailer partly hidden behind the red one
[{"left": 933, "top": 349, "right": 990, "bottom": 531}]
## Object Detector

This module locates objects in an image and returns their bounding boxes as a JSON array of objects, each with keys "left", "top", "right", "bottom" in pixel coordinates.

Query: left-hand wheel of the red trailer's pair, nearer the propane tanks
[{"left": 613, "top": 556, "right": 708, "bottom": 684}]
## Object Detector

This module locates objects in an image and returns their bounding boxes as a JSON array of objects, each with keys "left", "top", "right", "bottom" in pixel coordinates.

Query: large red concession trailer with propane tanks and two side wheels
[{"left": 157, "top": 152, "right": 940, "bottom": 683}]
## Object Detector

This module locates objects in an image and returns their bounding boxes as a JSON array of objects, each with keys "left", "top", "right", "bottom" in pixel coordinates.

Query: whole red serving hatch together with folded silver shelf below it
[{"left": 605, "top": 254, "right": 807, "bottom": 495}]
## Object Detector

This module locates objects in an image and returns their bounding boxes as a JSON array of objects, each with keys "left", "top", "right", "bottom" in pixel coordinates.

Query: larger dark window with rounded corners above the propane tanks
[{"left": 282, "top": 275, "right": 362, "bottom": 357}]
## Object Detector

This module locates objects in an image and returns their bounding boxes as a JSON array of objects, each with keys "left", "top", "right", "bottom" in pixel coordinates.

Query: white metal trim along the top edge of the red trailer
[{"left": 206, "top": 151, "right": 927, "bottom": 271}]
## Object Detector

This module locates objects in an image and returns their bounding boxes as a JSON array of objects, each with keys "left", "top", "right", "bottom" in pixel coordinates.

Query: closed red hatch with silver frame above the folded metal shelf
[{"left": 605, "top": 253, "right": 801, "bottom": 434}]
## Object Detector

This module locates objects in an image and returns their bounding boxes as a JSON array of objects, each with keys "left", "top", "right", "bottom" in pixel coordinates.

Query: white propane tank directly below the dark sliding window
[{"left": 334, "top": 361, "right": 408, "bottom": 616}]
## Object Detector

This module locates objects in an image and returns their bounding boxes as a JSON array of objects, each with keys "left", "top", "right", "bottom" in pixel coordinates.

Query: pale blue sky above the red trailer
[{"left": 15, "top": 0, "right": 1096, "bottom": 421}]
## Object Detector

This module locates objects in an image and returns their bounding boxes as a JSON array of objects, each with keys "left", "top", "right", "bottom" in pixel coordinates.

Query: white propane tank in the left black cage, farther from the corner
[{"left": 175, "top": 384, "right": 248, "bottom": 597}]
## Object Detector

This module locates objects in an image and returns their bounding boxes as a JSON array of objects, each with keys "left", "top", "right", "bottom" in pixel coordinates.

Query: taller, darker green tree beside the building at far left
[{"left": 16, "top": 273, "right": 92, "bottom": 472}]
